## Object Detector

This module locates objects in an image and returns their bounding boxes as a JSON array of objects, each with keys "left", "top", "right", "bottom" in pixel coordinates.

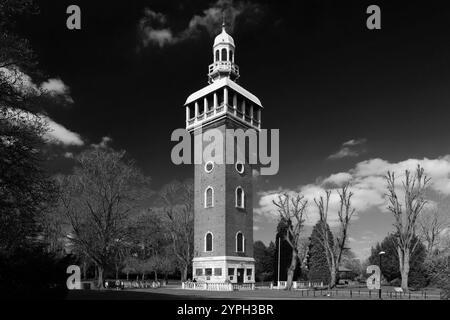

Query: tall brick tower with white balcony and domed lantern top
[{"left": 185, "top": 25, "right": 262, "bottom": 283}]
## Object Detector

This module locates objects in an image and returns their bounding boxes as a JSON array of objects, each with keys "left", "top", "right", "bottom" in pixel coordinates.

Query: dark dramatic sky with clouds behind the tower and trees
[{"left": 17, "top": 0, "right": 450, "bottom": 258}]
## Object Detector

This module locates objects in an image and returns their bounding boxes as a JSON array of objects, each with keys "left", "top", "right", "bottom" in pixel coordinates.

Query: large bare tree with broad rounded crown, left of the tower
[{"left": 60, "top": 149, "right": 148, "bottom": 288}]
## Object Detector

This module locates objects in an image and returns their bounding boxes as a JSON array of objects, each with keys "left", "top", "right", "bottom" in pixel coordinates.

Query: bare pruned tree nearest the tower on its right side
[{"left": 272, "top": 193, "right": 308, "bottom": 290}]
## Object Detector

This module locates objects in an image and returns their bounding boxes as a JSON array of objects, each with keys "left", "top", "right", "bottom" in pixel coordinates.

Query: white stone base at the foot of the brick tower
[{"left": 192, "top": 256, "right": 255, "bottom": 284}]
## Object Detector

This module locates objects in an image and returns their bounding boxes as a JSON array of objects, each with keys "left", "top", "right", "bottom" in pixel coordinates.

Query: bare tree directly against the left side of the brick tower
[{"left": 160, "top": 180, "right": 194, "bottom": 281}]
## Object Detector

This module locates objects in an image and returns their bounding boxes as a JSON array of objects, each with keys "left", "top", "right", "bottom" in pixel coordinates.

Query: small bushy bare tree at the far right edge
[{"left": 418, "top": 192, "right": 450, "bottom": 255}]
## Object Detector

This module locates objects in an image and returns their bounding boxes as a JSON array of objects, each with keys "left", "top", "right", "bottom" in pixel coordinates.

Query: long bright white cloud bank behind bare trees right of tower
[{"left": 254, "top": 155, "right": 450, "bottom": 226}]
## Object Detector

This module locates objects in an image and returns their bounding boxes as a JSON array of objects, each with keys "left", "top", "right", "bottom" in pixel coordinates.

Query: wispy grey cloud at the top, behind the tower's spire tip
[{"left": 138, "top": 0, "right": 262, "bottom": 48}]
